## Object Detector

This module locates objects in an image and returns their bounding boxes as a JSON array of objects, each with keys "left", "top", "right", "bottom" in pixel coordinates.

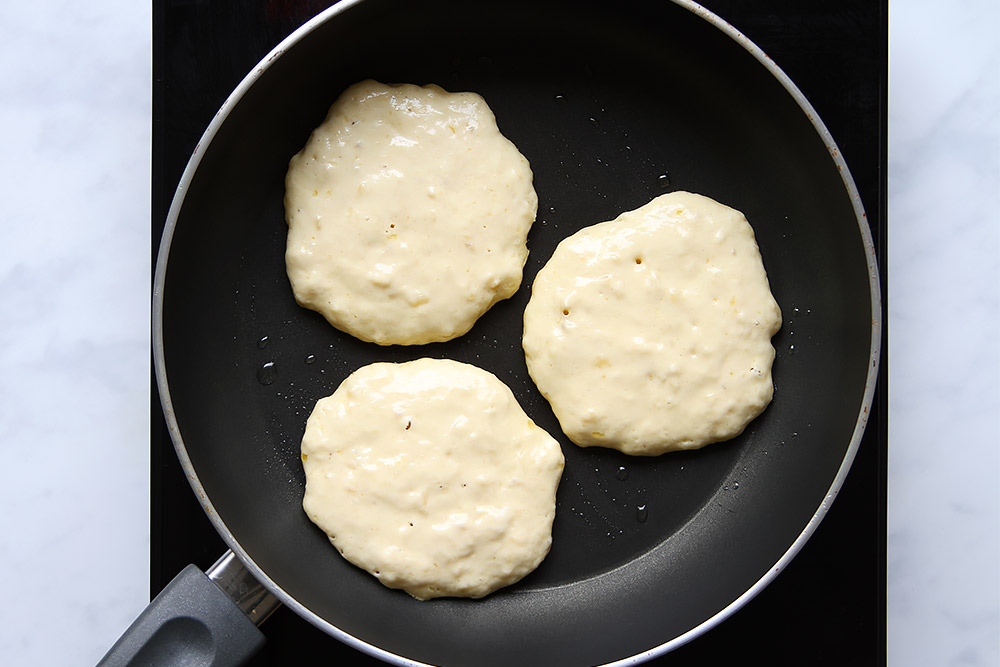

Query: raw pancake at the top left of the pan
[{"left": 285, "top": 81, "right": 538, "bottom": 345}]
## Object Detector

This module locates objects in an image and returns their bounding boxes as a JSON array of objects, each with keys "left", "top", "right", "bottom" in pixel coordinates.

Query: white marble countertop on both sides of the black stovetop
[{"left": 0, "top": 0, "right": 1000, "bottom": 667}]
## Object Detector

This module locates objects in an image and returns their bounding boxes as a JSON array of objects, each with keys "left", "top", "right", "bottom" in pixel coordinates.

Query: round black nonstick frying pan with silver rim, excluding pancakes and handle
[{"left": 107, "top": 0, "right": 881, "bottom": 665}]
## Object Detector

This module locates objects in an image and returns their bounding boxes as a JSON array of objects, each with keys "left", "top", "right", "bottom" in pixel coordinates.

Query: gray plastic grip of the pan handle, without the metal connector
[{"left": 98, "top": 565, "right": 264, "bottom": 667}]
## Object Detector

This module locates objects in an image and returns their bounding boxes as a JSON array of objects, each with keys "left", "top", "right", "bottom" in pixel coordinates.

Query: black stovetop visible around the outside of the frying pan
[{"left": 150, "top": 0, "right": 888, "bottom": 666}]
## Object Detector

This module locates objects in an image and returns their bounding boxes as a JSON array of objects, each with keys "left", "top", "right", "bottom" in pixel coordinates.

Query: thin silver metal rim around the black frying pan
[{"left": 151, "top": 0, "right": 883, "bottom": 667}]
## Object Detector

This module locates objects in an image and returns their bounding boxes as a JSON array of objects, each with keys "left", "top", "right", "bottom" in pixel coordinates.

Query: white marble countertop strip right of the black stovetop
[{"left": 888, "top": 0, "right": 1000, "bottom": 666}]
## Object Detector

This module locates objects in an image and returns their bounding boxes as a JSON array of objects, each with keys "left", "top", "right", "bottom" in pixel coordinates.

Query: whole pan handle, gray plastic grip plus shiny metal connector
[{"left": 98, "top": 551, "right": 280, "bottom": 667}]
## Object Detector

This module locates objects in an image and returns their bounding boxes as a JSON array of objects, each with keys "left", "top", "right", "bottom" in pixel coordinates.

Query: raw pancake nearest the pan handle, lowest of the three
[{"left": 302, "top": 359, "right": 563, "bottom": 600}]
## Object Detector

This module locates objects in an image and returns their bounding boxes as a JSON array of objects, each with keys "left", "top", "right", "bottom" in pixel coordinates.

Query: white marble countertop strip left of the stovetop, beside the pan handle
[{"left": 0, "top": 0, "right": 152, "bottom": 665}]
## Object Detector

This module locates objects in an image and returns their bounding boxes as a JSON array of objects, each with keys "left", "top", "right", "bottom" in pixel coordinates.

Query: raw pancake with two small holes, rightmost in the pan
[{"left": 523, "top": 192, "right": 781, "bottom": 455}]
